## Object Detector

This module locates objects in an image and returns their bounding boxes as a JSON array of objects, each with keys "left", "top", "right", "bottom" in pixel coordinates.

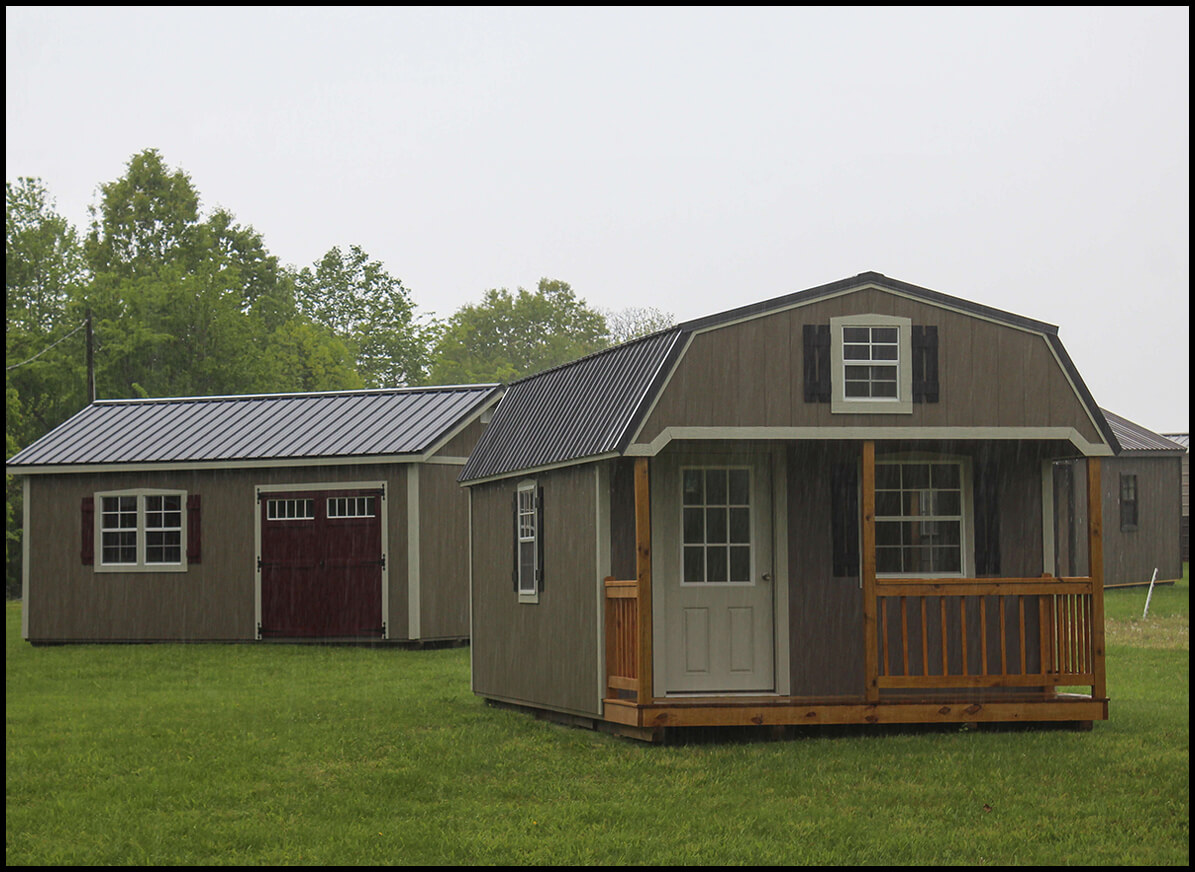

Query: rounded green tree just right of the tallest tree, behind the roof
[{"left": 295, "top": 245, "right": 428, "bottom": 387}]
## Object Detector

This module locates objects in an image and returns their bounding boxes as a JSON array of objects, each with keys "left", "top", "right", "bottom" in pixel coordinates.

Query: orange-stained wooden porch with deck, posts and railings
[{"left": 603, "top": 442, "right": 1108, "bottom": 730}]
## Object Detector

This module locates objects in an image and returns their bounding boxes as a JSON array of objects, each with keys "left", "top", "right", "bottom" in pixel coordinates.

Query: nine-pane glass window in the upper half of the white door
[{"left": 681, "top": 467, "right": 752, "bottom": 584}]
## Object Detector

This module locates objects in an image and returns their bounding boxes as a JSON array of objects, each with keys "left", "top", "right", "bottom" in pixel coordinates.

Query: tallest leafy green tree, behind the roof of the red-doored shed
[{"left": 86, "top": 149, "right": 361, "bottom": 397}]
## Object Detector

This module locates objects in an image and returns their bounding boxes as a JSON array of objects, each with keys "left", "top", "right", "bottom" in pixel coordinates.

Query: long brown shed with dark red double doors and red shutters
[{"left": 8, "top": 385, "right": 501, "bottom": 643}]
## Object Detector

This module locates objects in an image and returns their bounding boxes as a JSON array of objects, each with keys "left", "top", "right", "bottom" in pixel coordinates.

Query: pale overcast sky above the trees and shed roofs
[{"left": 5, "top": 6, "right": 1190, "bottom": 431}]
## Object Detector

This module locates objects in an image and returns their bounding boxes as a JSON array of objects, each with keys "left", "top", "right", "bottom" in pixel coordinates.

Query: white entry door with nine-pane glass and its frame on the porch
[{"left": 652, "top": 454, "right": 776, "bottom": 693}]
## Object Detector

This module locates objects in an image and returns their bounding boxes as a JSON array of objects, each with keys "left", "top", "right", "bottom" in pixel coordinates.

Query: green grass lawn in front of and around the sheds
[{"left": 5, "top": 576, "right": 1189, "bottom": 865}]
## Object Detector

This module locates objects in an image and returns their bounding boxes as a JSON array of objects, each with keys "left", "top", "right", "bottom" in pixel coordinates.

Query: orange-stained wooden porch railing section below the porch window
[{"left": 875, "top": 578, "right": 1097, "bottom": 689}]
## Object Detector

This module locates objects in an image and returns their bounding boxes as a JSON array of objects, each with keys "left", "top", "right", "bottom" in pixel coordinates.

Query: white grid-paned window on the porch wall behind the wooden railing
[{"left": 876, "top": 461, "right": 964, "bottom": 576}]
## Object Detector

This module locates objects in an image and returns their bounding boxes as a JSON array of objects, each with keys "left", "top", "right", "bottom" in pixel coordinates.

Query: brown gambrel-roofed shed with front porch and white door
[{"left": 461, "top": 272, "right": 1116, "bottom": 736}]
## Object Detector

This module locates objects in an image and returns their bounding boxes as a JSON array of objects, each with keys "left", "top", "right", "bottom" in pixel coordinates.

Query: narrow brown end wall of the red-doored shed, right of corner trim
[{"left": 419, "top": 463, "right": 468, "bottom": 639}]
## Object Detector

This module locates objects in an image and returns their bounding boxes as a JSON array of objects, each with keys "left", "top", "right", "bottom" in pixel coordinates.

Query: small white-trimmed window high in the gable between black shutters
[{"left": 829, "top": 315, "right": 913, "bottom": 414}]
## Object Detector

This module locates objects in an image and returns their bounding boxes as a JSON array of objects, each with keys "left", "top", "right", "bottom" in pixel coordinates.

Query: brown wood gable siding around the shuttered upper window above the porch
[{"left": 637, "top": 289, "right": 1102, "bottom": 443}]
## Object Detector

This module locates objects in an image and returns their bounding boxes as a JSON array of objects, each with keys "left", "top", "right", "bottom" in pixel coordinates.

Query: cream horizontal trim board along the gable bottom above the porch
[{"left": 626, "top": 426, "right": 1113, "bottom": 458}]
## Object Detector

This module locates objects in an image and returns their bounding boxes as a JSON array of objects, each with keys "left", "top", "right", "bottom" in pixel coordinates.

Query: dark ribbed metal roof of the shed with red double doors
[{"left": 8, "top": 385, "right": 500, "bottom": 472}]
